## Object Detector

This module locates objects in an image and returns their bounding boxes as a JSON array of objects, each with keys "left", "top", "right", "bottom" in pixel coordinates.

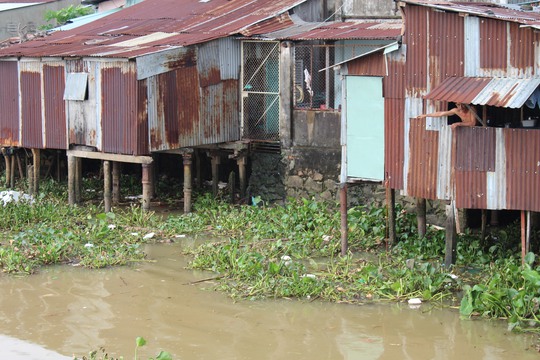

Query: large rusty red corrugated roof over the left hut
[{"left": 0, "top": 0, "right": 306, "bottom": 58}]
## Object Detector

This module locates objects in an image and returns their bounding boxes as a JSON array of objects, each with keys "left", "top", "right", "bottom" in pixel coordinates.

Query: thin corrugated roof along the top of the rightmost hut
[{"left": 401, "top": 0, "right": 540, "bottom": 28}]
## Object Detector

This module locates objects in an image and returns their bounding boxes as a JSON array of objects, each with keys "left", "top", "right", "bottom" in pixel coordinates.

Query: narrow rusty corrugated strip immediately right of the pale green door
[{"left": 384, "top": 98, "right": 405, "bottom": 189}]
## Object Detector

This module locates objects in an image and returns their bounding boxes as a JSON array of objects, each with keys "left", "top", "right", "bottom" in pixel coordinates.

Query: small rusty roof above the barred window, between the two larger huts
[{"left": 263, "top": 15, "right": 402, "bottom": 40}]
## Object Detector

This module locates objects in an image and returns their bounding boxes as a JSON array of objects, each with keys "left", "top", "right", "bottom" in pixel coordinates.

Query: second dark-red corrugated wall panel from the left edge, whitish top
[{"left": 19, "top": 61, "right": 44, "bottom": 149}]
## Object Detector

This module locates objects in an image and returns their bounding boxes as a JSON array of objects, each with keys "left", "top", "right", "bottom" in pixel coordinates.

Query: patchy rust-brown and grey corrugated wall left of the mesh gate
[{"left": 147, "top": 39, "right": 240, "bottom": 151}]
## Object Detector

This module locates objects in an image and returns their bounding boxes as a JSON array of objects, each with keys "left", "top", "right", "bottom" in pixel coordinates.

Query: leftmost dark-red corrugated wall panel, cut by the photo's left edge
[{"left": 0, "top": 61, "right": 19, "bottom": 146}]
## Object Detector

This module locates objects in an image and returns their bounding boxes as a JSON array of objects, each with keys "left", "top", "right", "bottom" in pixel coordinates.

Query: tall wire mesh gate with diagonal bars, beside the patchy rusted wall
[{"left": 242, "top": 41, "right": 280, "bottom": 140}]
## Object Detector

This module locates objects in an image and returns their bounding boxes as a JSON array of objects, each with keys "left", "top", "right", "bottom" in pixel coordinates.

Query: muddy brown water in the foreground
[{"left": 0, "top": 240, "right": 540, "bottom": 360}]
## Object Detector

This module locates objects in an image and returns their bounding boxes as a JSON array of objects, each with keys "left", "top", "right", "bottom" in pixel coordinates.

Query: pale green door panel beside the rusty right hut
[{"left": 346, "top": 76, "right": 384, "bottom": 181}]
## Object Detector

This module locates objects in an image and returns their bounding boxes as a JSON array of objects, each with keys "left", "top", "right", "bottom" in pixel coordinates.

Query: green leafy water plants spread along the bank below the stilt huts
[{"left": 0, "top": 180, "right": 540, "bottom": 332}]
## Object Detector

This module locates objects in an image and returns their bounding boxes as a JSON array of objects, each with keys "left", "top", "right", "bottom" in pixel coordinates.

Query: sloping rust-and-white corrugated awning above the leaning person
[{"left": 424, "top": 77, "right": 540, "bottom": 108}]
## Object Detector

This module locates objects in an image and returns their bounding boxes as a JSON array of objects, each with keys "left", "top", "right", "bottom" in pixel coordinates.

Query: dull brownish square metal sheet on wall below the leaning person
[{"left": 454, "top": 127, "right": 496, "bottom": 172}]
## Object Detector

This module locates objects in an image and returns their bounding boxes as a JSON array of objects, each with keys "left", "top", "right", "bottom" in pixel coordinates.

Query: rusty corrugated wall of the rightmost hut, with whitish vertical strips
[{"left": 392, "top": 5, "right": 540, "bottom": 211}]
